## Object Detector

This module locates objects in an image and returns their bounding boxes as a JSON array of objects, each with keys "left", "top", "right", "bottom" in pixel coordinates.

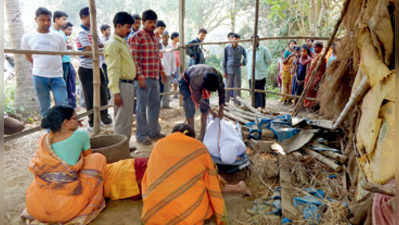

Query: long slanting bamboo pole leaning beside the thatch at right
[{"left": 292, "top": 0, "right": 350, "bottom": 116}]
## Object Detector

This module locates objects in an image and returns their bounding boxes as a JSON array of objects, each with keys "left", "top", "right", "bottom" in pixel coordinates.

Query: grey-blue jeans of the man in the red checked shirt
[{"left": 134, "top": 79, "right": 161, "bottom": 141}]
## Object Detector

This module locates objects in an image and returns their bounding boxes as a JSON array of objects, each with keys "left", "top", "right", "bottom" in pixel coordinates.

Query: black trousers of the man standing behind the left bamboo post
[{"left": 78, "top": 67, "right": 108, "bottom": 123}]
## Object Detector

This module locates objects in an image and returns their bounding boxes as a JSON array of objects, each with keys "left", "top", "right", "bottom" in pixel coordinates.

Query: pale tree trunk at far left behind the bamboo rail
[{"left": 5, "top": 0, "right": 39, "bottom": 114}]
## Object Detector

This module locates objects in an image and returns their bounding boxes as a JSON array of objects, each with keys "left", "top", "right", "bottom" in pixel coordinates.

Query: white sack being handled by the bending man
[{"left": 204, "top": 118, "right": 246, "bottom": 164}]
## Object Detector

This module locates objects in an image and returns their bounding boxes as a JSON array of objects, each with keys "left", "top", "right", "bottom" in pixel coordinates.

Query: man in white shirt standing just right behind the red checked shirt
[{"left": 161, "top": 31, "right": 177, "bottom": 109}]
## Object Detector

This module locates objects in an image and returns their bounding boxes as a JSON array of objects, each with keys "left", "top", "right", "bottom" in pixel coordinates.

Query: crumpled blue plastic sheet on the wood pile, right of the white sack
[{"left": 246, "top": 114, "right": 300, "bottom": 142}]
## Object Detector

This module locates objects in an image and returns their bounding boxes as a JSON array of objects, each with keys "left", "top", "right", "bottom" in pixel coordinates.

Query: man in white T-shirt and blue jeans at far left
[{"left": 21, "top": 8, "right": 68, "bottom": 117}]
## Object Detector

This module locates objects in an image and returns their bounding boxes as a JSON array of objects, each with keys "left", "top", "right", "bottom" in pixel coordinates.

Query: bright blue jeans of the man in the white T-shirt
[{"left": 33, "top": 76, "right": 68, "bottom": 117}]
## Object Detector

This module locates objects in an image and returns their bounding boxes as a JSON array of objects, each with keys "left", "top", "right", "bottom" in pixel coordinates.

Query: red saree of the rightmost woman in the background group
[{"left": 303, "top": 54, "right": 326, "bottom": 108}]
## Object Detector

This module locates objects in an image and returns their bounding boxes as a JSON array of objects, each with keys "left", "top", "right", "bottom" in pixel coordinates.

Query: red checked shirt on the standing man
[{"left": 129, "top": 30, "right": 163, "bottom": 80}]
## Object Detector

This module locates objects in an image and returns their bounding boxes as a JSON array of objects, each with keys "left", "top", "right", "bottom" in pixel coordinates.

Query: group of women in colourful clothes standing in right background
[{"left": 278, "top": 39, "right": 336, "bottom": 111}]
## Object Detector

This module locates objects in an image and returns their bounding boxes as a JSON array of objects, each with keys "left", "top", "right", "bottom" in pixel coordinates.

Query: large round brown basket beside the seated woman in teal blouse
[{"left": 90, "top": 135, "right": 129, "bottom": 163}]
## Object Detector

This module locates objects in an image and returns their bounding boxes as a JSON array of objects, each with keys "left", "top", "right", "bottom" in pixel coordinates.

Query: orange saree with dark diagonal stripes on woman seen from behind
[{"left": 141, "top": 133, "right": 226, "bottom": 225}]
